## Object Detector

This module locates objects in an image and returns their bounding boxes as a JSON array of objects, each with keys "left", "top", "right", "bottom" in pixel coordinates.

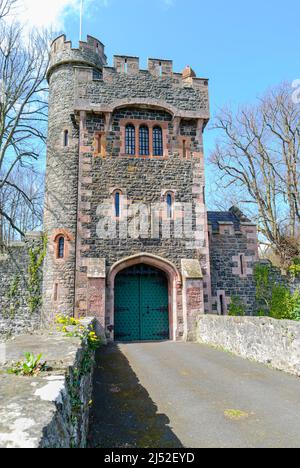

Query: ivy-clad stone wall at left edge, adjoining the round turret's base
[{"left": 0, "top": 233, "right": 42, "bottom": 339}]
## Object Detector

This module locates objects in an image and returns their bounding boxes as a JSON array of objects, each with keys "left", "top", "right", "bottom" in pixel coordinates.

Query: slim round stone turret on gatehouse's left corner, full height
[{"left": 43, "top": 36, "right": 106, "bottom": 321}]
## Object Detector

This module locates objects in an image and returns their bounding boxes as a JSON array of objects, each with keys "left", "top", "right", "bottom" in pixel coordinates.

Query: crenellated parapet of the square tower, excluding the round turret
[{"left": 74, "top": 56, "right": 210, "bottom": 120}]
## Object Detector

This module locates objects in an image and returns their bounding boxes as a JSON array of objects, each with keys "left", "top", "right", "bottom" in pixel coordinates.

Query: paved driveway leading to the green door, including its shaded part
[{"left": 89, "top": 342, "right": 300, "bottom": 448}]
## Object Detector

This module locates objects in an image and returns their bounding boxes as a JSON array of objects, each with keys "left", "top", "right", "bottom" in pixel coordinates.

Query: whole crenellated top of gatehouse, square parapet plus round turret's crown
[{"left": 47, "top": 35, "right": 210, "bottom": 120}]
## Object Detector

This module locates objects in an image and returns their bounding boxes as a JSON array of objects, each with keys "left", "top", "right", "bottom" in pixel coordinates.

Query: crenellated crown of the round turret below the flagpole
[{"left": 47, "top": 34, "right": 107, "bottom": 81}]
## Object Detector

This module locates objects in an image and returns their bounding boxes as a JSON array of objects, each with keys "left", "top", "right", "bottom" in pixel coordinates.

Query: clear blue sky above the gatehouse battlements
[{"left": 59, "top": 0, "right": 300, "bottom": 157}]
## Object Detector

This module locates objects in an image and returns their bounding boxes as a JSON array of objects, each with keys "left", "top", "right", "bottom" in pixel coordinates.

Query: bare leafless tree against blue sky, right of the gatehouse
[{"left": 211, "top": 84, "right": 300, "bottom": 265}]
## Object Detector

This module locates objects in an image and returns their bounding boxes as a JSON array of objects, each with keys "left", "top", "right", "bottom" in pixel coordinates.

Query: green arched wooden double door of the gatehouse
[{"left": 115, "top": 265, "right": 169, "bottom": 341}]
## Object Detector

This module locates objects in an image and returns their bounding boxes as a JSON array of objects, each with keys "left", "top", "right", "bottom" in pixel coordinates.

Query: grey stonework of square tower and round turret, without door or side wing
[{"left": 43, "top": 36, "right": 210, "bottom": 337}]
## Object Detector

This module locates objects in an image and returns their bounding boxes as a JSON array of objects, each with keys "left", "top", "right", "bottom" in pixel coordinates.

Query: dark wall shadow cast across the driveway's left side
[{"left": 89, "top": 345, "right": 183, "bottom": 448}]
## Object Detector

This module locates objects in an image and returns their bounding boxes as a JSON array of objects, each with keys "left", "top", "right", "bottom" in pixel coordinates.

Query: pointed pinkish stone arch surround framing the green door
[{"left": 106, "top": 253, "right": 182, "bottom": 340}]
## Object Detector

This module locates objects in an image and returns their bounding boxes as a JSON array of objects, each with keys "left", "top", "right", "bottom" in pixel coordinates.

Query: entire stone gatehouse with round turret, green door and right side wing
[{"left": 42, "top": 36, "right": 258, "bottom": 341}]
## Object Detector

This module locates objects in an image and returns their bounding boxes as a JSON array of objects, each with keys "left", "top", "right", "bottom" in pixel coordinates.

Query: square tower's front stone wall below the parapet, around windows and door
[{"left": 75, "top": 106, "right": 210, "bottom": 338}]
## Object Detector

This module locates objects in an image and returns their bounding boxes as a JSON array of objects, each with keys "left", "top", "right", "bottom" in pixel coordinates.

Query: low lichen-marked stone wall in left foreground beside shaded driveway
[{"left": 0, "top": 319, "right": 95, "bottom": 448}]
